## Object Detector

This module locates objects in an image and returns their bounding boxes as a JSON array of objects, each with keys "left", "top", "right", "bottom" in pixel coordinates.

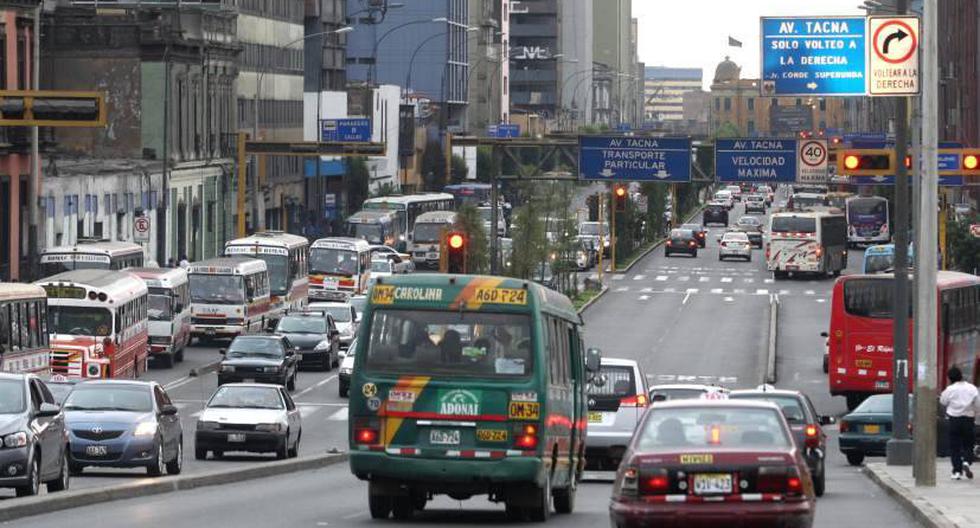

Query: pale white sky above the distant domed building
[{"left": 632, "top": 0, "right": 864, "bottom": 90}]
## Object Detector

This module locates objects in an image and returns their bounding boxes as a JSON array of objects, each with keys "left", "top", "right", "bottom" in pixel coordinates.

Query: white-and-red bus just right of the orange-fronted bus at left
[{"left": 126, "top": 268, "right": 191, "bottom": 367}]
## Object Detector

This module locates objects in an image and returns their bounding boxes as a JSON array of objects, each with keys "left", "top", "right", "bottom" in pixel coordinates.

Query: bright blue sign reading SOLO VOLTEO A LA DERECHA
[{"left": 761, "top": 17, "right": 868, "bottom": 96}]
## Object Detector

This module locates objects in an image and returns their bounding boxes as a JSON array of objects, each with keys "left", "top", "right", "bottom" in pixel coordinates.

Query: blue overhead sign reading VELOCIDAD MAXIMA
[{"left": 715, "top": 138, "right": 797, "bottom": 183}]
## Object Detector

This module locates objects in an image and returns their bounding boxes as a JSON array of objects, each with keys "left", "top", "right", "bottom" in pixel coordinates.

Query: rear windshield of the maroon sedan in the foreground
[{"left": 636, "top": 406, "right": 791, "bottom": 452}]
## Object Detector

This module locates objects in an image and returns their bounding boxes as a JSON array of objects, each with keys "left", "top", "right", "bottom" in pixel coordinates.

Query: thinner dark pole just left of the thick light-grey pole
[{"left": 885, "top": 0, "right": 918, "bottom": 466}]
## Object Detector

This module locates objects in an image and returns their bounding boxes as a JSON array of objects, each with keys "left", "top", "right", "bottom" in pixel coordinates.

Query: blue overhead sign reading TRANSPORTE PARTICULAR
[{"left": 579, "top": 136, "right": 691, "bottom": 182}]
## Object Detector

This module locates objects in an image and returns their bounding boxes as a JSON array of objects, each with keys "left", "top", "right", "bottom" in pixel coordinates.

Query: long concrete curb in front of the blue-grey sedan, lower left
[{"left": 0, "top": 453, "right": 347, "bottom": 522}]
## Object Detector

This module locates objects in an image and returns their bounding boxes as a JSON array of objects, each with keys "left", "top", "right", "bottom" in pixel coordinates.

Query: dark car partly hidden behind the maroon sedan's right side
[{"left": 728, "top": 385, "right": 834, "bottom": 497}]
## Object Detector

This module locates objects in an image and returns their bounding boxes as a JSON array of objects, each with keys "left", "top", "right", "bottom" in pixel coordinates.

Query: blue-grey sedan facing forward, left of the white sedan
[{"left": 64, "top": 380, "right": 184, "bottom": 476}]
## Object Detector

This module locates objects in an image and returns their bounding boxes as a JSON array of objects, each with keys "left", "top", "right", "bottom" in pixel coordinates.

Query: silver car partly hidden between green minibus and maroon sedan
[{"left": 585, "top": 357, "right": 649, "bottom": 471}]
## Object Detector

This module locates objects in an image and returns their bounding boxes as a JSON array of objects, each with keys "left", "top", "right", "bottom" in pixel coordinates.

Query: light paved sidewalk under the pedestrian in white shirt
[{"left": 864, "top": 458, "right": 980, "bottom": 528}]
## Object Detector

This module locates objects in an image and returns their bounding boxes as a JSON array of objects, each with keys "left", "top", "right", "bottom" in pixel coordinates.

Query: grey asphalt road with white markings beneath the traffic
[{"left": 5, "top": 191, "right": 918, "bottom": 528}]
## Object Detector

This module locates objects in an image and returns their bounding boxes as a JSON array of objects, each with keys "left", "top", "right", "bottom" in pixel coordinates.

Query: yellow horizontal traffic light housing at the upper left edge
[{"left": 0, "top": 90, "right": 106, "bottom": 127}]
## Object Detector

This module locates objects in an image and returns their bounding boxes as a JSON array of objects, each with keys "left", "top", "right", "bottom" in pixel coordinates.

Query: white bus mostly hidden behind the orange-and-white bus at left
[{"left": 40, "top": 240, "right": 146, "bottom": 277}]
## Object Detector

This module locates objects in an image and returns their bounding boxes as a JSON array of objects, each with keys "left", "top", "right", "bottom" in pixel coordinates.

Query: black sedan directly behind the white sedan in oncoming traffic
[{"left": 218, "top": 336, "right": 299, "bottom": 390}]
